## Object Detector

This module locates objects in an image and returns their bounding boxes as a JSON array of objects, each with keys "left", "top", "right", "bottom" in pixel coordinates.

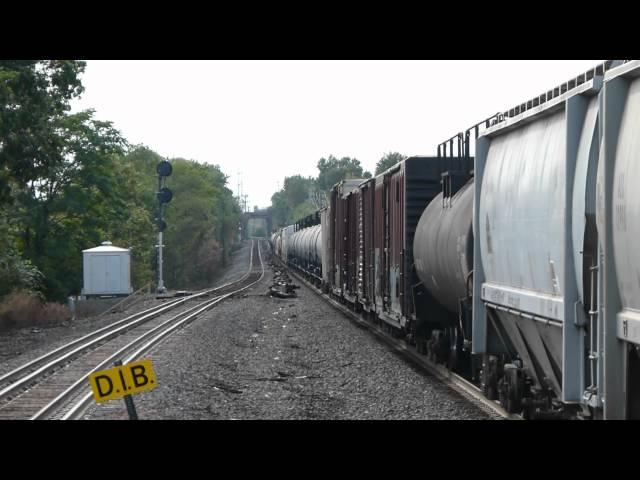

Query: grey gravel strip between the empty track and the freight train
[{"left": 85, "top": 244, "right": 497, "bottom": 420}]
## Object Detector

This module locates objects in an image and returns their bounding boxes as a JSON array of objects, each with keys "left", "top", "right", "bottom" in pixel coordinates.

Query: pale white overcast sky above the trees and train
[{"left": 73, "top": 60, "right": 600, "bottom": 208}]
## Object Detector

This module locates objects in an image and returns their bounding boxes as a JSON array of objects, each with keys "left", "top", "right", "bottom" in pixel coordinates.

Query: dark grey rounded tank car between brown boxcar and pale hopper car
[{"left": 413, "top": 176, "right": 474, "bottom": 373}]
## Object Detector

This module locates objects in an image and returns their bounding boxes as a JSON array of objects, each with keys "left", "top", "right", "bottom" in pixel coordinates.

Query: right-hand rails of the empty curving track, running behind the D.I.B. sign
[{"left": 37, "top": 242, "right": 264, "bottom": 420}]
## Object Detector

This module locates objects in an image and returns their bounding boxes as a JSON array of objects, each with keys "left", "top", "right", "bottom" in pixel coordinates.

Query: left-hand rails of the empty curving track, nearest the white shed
[{"left": 0, "top": 241, "right": 254, "bottom": 401}]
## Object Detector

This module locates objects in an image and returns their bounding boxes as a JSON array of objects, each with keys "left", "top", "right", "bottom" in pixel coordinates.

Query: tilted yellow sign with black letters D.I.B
[{"left": 89, "top": 360, "right": 158, "bottom": 403}]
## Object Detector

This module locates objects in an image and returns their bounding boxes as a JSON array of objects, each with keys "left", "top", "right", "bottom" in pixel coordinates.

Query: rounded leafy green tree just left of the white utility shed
[{"left": 14, "top": 111, "right": 129, "bottom": 300}]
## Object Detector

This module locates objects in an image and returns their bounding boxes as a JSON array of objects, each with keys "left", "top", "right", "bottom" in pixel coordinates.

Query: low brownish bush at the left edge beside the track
[{"left": 0, "top": 292, "right": 71, "bottom": 330}]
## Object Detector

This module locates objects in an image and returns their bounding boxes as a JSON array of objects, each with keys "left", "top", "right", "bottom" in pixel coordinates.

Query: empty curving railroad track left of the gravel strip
[{"left": 0, "top": 241, "right": 264, "bottom": 420}]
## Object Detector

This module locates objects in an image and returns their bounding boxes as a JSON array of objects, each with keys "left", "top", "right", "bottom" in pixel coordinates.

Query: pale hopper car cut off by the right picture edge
[{"left": 596, "top": 60, "right": 640, "bottom": 419}]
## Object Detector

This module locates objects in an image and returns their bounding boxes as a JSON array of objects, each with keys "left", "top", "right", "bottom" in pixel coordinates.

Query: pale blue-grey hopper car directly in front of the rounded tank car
[{"left": 473, "top": 79, "right": 600, "bottom": 411}]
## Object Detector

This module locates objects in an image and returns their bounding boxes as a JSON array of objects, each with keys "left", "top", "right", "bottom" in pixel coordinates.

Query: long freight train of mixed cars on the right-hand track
[{"left": 271, "top": 60, "right": 640, "bottom": 419}]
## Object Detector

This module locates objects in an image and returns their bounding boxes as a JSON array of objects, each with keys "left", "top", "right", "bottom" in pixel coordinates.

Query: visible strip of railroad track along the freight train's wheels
[{"left": 274, "top": 256, "right": 522, "bottom": 420}]
